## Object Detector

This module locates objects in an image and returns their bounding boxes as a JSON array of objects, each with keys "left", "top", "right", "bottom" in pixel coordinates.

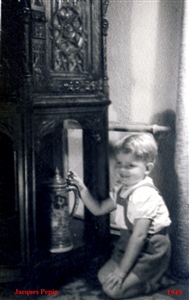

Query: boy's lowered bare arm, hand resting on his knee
[{"left": 105, "top": 219, "right": 151, "bottom": 288}]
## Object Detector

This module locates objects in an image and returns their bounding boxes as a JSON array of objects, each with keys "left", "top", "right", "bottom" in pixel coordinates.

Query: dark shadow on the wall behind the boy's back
[{"left": 152, "top": 110, "right": 178, "bottom": 274}]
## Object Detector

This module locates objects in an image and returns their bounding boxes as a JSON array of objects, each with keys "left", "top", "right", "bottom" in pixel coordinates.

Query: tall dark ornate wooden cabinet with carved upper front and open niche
[{"left": 0, "top": 0, "right": 110, "bottom": 284}]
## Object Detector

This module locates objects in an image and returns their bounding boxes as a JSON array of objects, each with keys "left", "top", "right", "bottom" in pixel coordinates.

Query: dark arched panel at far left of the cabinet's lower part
[{"left": 0, "top": 132, "right": 21, "bottom": 265}]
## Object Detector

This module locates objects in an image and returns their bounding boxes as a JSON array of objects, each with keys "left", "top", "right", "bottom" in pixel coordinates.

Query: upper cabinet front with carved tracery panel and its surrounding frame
[{"left": 31, "top": 0, "right": 103, "bottom": 94}]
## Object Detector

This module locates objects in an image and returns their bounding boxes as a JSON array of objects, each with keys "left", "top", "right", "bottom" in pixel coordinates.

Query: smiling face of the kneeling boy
[{"left": 115, "top": 151, "right": 150, "bottom": 186}]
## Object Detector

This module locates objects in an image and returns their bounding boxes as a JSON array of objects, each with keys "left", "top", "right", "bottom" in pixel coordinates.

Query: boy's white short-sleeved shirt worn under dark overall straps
[{"left": 110, "top": 177, "right": 171, "bottom": 234}]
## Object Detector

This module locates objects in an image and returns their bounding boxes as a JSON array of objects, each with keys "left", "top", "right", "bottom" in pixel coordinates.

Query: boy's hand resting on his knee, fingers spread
[{"left": 103, "top": 267, "right": 126, "bottom": 289}]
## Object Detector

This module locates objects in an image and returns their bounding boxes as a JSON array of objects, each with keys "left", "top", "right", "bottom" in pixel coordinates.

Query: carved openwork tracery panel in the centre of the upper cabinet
[{"left": 50, "top": 1, "right": 89, "bottom": 74}]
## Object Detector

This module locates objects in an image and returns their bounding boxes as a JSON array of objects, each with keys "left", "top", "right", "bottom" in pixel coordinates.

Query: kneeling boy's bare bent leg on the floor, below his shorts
[{"left": 98, "top": 259, "right": 146, "bottom": 299}]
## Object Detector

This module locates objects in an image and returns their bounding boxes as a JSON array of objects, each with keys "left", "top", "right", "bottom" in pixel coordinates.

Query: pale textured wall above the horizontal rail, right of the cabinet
[{"left": 106, "top": 0, "right": 182, "bottom": 124}]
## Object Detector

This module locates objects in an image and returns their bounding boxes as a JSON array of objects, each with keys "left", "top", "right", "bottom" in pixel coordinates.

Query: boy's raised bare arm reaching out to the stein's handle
[{"left": 68, "top": 171, "right": 116, "bottom": 216}]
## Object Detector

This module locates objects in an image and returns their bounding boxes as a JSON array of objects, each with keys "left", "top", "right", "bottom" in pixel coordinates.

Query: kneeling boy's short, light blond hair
[{"left": 115, "top": 132, "right": 158, "bottom": 163}]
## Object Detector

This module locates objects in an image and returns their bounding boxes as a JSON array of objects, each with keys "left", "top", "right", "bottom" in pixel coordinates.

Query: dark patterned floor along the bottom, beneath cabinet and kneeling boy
[{"left": 0, "top": 274, "right": 189, "bottom": 300}]
